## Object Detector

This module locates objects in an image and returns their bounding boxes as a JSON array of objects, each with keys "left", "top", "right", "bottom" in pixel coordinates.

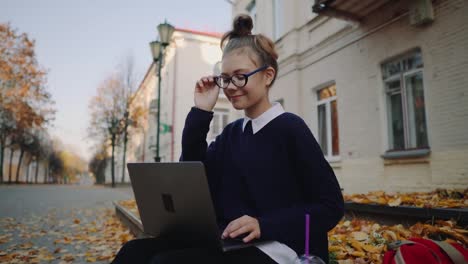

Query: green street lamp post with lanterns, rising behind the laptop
[{"left": 150, "top": 22, "right": 175, "bottom": 162}]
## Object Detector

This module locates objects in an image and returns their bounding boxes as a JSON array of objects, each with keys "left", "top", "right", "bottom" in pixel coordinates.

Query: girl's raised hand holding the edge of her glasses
[{"left": 194, "top": 76, "right": 219, "bottom": 111}]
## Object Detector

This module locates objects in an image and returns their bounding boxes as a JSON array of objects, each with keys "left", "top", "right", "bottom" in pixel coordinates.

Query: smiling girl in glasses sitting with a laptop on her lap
[{"left": 114, "top": 15, "right": 344, "bottom": 264}]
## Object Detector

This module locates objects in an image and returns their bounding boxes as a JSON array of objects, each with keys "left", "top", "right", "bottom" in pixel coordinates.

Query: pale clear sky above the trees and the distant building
[{"left": 0, "top": 0, "right": 232, "bottom": 159}]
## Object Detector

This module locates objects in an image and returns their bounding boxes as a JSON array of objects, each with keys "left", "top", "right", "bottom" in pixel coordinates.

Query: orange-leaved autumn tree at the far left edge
[{"left": 0, "top": 23, "right": 55, "bottom": 182}]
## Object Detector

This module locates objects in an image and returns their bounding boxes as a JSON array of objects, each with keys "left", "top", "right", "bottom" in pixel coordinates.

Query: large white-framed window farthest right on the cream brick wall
[{"left": 382, "top": 50, "right": 429, "bottom": 151}]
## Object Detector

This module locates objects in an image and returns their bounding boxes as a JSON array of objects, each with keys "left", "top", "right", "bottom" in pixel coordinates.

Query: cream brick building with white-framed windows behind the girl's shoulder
[{"left": 233, "top": 0, "right": 468, "bottom": 193}]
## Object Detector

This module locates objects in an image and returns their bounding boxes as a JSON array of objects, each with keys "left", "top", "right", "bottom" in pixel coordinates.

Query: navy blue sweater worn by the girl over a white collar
[{"left": 181, "top": 107, "right": 344, "bottom": 262}]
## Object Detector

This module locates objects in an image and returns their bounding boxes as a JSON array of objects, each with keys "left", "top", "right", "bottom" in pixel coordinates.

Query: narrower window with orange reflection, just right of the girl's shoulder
[{"left": 317, "top": 84, "right": 340, "bottom": 160}]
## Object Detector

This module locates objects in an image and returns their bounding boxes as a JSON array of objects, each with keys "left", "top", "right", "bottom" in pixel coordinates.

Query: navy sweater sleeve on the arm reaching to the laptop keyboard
[{"left": 259, "top": 119, "right": 344, "bottom": 254}]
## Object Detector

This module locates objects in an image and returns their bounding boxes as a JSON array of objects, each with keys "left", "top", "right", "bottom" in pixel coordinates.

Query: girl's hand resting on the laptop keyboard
[{"left": 221, "top": 215, "right": 260, "bottom": 243}]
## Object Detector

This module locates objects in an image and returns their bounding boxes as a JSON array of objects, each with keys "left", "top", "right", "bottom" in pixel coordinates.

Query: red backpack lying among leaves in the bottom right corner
[{"left": 383, "top": 238, "right": 468, "bottom": 264}]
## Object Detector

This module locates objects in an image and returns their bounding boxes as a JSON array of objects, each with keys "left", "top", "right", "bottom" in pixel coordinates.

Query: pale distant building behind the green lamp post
[{"left": 111, "top": 28, "right": 243, "bottom": 182}]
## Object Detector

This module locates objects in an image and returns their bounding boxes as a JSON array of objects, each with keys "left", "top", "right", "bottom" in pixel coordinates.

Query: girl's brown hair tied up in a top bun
[{"left": 221, "top": 14, "right": 278, "bottom": 87}]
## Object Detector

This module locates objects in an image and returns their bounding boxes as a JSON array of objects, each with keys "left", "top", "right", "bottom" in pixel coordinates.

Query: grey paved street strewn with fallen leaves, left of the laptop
[{"left": 0, "top": 185, "right": 133, "bottom": 263}]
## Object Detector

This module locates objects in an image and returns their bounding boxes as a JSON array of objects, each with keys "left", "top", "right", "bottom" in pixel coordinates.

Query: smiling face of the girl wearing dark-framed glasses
[{"left": 221, "top": 49, "right": 274, "bottom": 113}]
